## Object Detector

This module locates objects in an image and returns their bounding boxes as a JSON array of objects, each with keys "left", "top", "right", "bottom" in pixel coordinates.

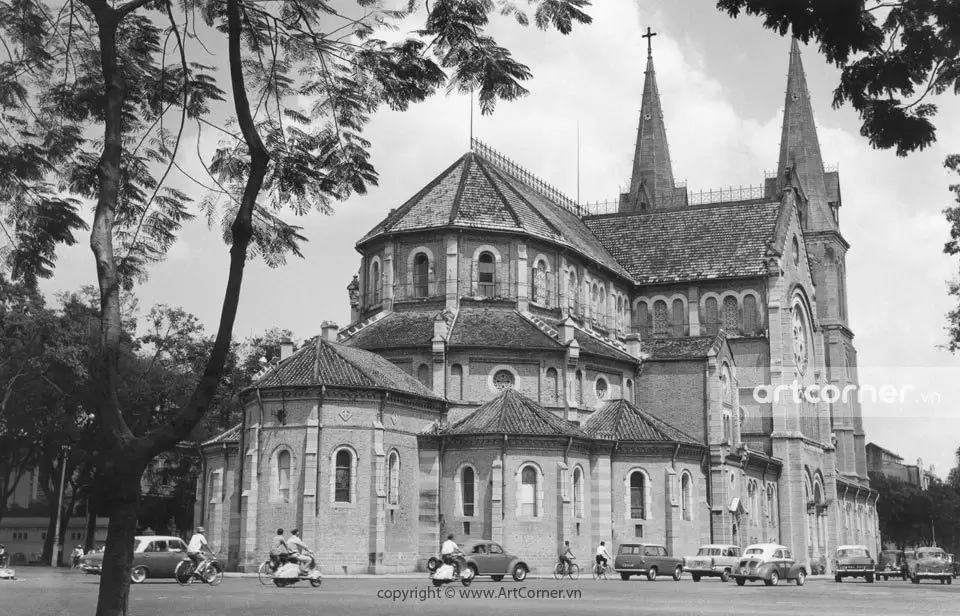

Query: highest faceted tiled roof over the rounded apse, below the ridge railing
[{"left": 358, "top": 152, "right": 628, "bottom": 277}]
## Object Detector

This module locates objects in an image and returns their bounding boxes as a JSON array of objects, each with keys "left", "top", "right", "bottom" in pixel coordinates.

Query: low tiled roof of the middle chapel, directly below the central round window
[{"left": 440, "top": 389, "right": 587, "bottom": 438}]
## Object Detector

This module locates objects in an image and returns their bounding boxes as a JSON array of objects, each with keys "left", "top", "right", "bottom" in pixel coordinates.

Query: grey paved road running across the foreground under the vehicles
[{"left": 0, "top": 568, "right": 960, "bottom": 616}]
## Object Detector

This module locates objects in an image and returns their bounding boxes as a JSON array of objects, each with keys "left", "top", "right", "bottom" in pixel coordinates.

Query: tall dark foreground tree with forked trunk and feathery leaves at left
[{"left": 0, "top": 0, "right": 590, "bottom": 615}]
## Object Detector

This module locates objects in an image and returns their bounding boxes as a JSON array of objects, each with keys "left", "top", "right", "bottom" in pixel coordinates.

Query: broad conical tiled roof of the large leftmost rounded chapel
[{"left": 251, "top": 337, "right": 440, "bottom": 399}]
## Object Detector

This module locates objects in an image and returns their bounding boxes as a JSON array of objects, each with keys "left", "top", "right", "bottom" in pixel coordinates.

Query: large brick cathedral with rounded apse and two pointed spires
[{"left": 195, "top": 41, "right": 879, "bottom": 573}]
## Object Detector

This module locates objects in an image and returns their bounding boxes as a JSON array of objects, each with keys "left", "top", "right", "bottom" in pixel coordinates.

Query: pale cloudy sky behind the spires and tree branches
[{"left": 35, "top": 0, "right": 960, "bottom": 477}]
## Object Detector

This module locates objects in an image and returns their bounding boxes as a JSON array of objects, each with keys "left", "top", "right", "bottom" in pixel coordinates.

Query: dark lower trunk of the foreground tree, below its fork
[{"left": 96, "top": 464, "right": 146, "bottom": 616}]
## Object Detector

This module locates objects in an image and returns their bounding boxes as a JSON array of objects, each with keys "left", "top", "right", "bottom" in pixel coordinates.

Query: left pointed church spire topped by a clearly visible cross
[{"left": 620, "top": 28, "right": 679, "bottom": 210}]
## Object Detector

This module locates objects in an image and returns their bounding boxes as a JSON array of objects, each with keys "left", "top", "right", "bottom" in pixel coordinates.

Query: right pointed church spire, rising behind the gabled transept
[{"left": 777, "top": 39, "right": 836, "bottom": 230}]
